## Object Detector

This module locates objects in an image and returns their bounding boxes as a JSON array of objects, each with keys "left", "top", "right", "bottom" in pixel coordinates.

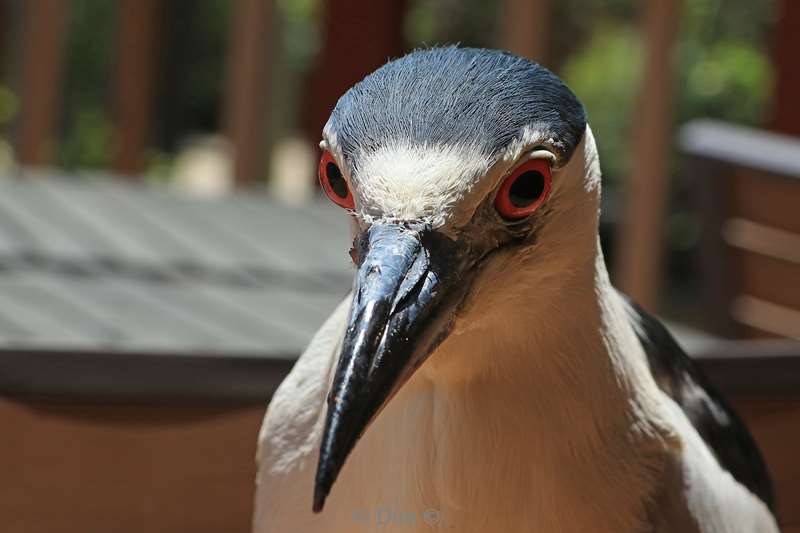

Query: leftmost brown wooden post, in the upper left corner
[{"left": 16, "top": 0, "right": 67, "bottom": 166}]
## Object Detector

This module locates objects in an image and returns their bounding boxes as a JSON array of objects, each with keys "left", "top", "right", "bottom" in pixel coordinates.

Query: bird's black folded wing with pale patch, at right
[{"left": 629, "top": 301, "right": 775, "bottom": 513}]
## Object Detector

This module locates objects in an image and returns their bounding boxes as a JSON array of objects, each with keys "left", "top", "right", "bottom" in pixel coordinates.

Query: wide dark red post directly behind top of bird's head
[{"left": 305, "top": 0, "right": 406, "bottom": 143}]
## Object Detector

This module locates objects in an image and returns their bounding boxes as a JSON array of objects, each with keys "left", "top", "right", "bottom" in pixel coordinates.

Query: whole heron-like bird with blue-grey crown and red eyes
[{"left": 253, "top": 46, "right": 778, "bottom": 533}]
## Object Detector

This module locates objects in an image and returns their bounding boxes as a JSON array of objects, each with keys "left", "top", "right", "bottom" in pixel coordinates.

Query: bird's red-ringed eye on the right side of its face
[{"left": 494, "top": 159, "right": 550, "bottom": 220}]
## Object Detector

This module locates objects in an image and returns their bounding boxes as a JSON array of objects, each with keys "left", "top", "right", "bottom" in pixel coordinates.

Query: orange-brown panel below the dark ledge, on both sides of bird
[{"left": 0, "top": 393, "right": 800, "bottom": 533}]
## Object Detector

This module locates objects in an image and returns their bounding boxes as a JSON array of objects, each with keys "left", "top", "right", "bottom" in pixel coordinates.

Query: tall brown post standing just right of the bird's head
[{"left": 616, "top": 0, "right": 679, "bottom": 311}]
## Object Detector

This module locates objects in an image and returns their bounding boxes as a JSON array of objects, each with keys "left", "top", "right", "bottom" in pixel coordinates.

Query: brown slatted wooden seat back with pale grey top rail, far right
[{"left": 681, "top": 121, "right": 800, "bottom": 339}]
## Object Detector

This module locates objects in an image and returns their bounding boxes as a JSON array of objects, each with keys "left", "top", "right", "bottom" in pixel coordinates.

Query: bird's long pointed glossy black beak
[{"left": 313, "top": 224, "right": 468, "bottom": 513}]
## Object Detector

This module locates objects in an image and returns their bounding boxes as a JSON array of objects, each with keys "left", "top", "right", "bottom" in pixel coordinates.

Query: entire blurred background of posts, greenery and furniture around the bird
[{"left": 0, "top": 0, "right": 800, "bottom": 532}]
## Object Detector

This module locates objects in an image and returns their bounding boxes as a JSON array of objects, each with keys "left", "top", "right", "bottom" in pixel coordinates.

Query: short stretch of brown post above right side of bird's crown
[{"left": 498, "top": 0, "right": 550, "bottom": 64}]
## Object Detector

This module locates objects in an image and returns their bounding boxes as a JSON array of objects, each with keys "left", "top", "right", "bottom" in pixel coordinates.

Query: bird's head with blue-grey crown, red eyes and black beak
[{"left": 314, "top": 47, "right": 599, "bottom": 512}]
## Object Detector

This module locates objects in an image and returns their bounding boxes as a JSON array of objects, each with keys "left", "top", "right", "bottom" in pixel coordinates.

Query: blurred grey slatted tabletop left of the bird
[{"left": 0, "top": 177, "right": 351, "bottom": 357}]
